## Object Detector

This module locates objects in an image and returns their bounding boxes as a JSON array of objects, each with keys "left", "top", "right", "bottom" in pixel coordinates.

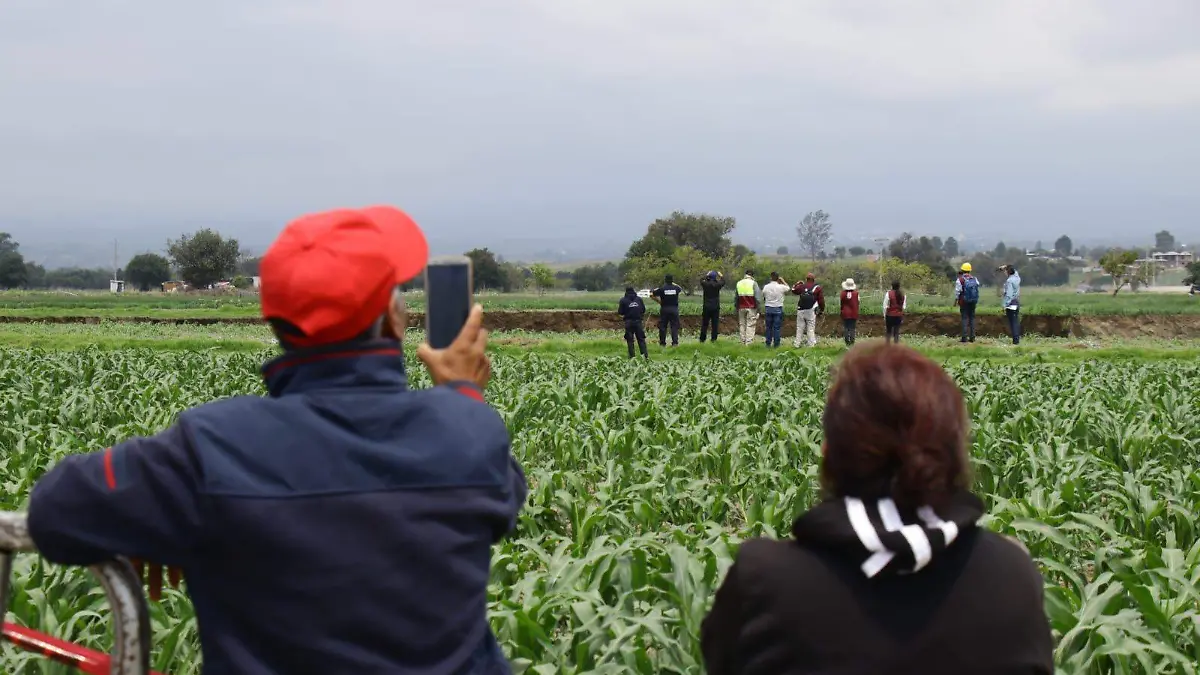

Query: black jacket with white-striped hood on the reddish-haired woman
[{"left": 701, "top": 492, "right": 1054, "bottom": 675}]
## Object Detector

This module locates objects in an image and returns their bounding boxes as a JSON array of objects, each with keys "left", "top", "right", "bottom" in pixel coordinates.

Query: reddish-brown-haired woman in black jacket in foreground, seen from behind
[{"left": 701, "top": 344, "right": 1054, "bottom": 675}]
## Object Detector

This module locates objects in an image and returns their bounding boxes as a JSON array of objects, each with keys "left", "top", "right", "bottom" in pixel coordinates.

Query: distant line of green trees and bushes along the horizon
[{"left": 0, "top": 218, "right": 1177, "bottom": 293}]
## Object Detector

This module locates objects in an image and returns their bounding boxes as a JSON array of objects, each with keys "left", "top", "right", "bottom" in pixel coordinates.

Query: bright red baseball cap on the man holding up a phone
[{"left": 259, "top": 207, "right": 430, "bottom": 347}]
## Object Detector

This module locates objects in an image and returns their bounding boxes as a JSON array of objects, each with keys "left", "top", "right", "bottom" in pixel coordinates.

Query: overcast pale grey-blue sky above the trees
[{"left": 0, "top": 0, "right": 1200, "bottom": 264}]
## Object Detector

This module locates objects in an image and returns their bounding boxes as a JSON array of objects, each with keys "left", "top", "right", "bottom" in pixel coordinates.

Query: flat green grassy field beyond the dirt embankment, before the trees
[{"left": 0, "top": 288, "right": 1200, "bottom": 318}]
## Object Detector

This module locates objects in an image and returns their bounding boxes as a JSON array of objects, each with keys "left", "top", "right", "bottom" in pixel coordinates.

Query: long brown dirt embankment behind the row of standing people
[{"left": 0, "top": 310, "right": 1200, "bottom": 338}]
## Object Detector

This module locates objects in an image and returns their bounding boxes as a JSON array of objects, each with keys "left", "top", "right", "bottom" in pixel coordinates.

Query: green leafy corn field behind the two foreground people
[{"left": 0, "top": 350, "right": 1200, "bottom": 675}]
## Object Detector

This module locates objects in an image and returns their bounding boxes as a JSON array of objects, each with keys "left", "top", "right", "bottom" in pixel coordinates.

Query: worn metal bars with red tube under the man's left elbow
[{"left": 0, "top": 512, "right": 152, "bottom": 675}]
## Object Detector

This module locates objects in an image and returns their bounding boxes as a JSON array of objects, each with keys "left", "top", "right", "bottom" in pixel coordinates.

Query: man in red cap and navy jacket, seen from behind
[{"left": 29, "top": 207, "right": 527, "bottom": 675}]
